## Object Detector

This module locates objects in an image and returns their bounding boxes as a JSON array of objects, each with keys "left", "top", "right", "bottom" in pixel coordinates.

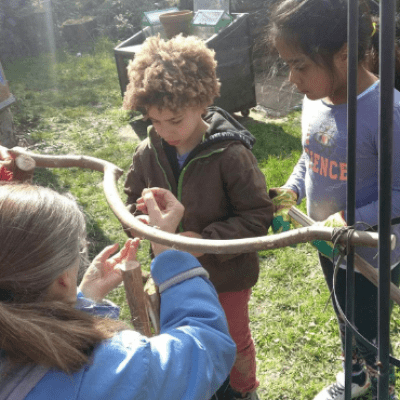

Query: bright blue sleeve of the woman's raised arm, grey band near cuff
[{"left": 78, "top": 250, "right": 236, "bottom": 400}]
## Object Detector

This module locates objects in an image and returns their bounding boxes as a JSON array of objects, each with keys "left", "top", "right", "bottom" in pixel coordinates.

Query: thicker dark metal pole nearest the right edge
[{"left": 378, "top": 0, "right": 396, "bottom": 400}]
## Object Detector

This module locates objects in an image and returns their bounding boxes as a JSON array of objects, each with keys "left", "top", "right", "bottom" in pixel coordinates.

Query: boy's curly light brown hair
[{"left": 123, "top": 35, "right": 221, "bottom": 114}]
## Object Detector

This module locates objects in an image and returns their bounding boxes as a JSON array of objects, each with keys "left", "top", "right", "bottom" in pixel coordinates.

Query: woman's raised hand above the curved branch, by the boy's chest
[{"left": 136, "top": 188, "right": 185, "bottom": 255}]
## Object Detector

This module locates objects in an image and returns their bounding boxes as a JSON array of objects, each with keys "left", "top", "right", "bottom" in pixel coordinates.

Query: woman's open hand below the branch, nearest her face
[{"left": 79, "top": 239, "right": 140, "bottom": 303}]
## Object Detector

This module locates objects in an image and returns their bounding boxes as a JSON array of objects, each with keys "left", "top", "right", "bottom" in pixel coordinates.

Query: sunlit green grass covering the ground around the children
[{"left": 3, "top": 40, "right": 400, "bottom": 400}]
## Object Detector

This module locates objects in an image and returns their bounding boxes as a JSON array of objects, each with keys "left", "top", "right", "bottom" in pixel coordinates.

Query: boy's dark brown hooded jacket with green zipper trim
[{"left": 125, "top": 107, "right": 273, "bottom": 293}]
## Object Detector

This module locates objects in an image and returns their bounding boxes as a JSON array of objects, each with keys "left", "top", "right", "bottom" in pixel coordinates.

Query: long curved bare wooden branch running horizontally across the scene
[{"left": 11, "top": 147, "right": 395, "bottom": 254}]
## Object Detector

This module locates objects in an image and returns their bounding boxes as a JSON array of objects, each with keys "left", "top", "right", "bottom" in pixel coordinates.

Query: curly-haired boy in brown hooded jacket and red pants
[{"left": 124, "top": 36, "right": 273, "bottom": 399}]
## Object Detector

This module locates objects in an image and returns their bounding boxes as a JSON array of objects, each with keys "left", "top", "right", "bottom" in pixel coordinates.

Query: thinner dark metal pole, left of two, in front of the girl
[{"left": 344, "top": 0, "right": 358, "bottom": 400}]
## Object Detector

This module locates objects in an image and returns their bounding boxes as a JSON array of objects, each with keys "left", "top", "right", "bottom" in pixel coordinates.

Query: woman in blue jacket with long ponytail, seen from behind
[{"left": 0, "top": 183, "right": 235, "bottom": 400}]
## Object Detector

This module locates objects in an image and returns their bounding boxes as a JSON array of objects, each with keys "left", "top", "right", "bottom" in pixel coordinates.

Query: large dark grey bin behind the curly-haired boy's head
[{"left": 114, "top": 13, "right": 257, "bottom": 116}]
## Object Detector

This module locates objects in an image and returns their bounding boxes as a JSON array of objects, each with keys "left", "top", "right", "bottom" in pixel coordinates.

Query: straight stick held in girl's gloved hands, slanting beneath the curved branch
[{"left": 288, "top": 207, "right": 400, "bottom": 305}]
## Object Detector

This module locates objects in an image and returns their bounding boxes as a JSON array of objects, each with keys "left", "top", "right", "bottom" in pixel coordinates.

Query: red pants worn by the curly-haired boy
[{"left": 219, "top": 289, "right": 260, "bottom": 393}]
